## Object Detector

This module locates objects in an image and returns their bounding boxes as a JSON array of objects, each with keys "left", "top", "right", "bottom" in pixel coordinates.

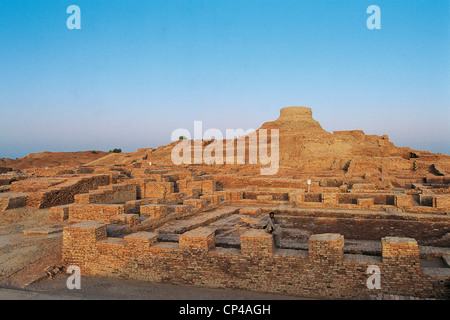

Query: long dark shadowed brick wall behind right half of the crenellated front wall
[{"left": 276, "top": 214, "right": 450, "bottom": 241}]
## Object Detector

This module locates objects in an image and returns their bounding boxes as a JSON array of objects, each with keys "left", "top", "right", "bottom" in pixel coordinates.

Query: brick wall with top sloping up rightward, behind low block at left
[{"left": 75, "top": 184, "right": 137, "bottom": 203}]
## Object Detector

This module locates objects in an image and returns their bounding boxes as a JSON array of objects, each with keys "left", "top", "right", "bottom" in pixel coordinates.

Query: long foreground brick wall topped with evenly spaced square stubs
[{"left": 63, "top": 226, "right": 450, "bottom": 299}]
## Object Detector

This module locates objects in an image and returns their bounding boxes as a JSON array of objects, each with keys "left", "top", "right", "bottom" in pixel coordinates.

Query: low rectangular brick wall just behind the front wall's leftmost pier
[{"left": 69, "top": 204, "right": 125, "bottom": 222}]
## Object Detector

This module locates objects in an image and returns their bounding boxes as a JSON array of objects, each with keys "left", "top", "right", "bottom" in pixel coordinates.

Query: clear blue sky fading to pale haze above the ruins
[{"left": 0, "top": 0, "right": 450, "bottom": 158}]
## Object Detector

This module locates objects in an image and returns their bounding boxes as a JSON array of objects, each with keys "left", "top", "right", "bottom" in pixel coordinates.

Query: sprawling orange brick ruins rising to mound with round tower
[{"left": 0, "top": 108, "right": 450, "bottom": 299}]
